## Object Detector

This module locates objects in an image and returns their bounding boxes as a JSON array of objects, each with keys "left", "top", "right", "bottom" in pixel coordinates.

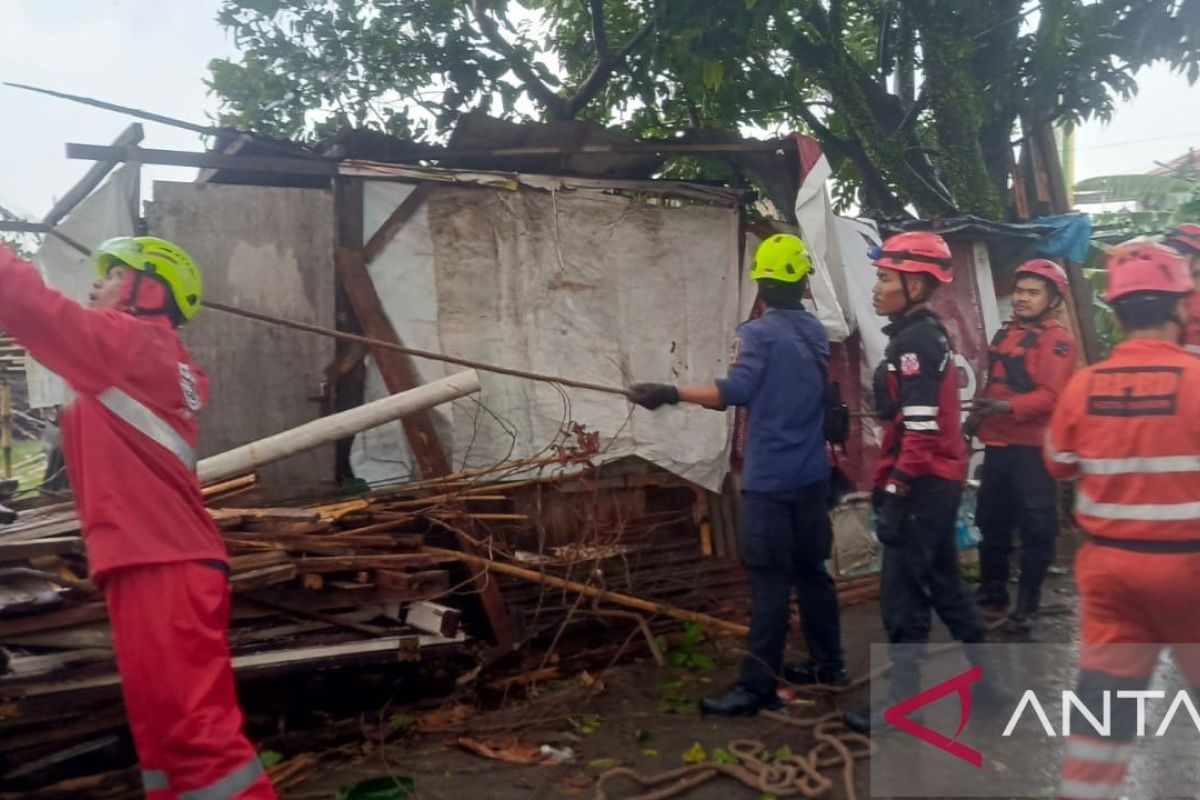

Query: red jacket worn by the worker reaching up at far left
[{"left": 0, "top": 246, "right": 227, "bottom": 581}]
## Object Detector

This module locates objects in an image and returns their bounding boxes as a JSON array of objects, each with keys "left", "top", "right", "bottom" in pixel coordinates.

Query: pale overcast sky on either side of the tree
[{"left": 0, "top": 0, "right": 1200, "bottom": 217}]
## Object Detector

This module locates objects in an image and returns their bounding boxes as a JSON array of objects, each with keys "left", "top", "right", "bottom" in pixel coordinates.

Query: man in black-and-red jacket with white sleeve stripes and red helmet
[{"left": 845, "top": 231, "right": 1004, "bottom": 733}]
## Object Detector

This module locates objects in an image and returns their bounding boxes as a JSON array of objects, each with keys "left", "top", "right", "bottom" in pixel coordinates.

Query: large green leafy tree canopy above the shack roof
[{"left": 209, "top": 0, "right": 1200, "bottom": 216}]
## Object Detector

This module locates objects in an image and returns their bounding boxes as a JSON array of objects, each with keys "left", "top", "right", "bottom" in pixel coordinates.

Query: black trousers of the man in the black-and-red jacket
[{"left": 880, "top": 476, "right": 984, "bottom": 664}]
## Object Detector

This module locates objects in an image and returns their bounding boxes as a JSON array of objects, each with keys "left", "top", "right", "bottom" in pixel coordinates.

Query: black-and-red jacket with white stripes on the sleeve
[{"left": 875, "top": 311, "right": 967, "bottom": 489}]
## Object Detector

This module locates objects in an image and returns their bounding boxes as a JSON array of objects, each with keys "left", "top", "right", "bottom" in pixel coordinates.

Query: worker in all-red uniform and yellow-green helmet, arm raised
[{"left": 0, "top": 236, "right": 276, "bottom": 800}]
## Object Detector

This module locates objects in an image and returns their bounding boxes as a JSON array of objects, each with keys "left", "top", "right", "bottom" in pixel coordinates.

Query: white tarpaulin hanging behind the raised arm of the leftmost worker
[{"left": 25, "top": 164, "right": 142, "bottom": 408}]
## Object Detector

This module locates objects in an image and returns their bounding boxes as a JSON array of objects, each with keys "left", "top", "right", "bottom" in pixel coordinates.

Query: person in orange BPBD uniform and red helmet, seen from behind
[{"left": 1045, "top": 242, "right": 1200, "bottom": 800}]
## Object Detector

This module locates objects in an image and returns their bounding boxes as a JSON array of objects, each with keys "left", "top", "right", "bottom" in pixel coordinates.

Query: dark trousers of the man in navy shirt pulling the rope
[{"left": 739, "top": 481, "right": 844, "bottom": 696}]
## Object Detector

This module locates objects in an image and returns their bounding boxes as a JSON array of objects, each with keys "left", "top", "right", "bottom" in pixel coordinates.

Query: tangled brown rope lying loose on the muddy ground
[{"left": 593, "top": 711, "right": 875, "bottom": 800}]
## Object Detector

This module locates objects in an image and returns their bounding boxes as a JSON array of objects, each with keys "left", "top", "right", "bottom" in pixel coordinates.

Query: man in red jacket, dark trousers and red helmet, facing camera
[{"left": 966, "top": 259, "right": 1076, "bottom": 633}]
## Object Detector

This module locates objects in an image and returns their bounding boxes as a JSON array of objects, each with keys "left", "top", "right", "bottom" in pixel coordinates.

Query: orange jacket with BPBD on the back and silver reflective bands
[{"left": 1045, "top": 339, "right": 1200, "bottom": 541}]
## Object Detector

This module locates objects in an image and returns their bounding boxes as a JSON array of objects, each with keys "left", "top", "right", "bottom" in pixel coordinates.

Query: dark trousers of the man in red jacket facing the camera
[{"left": 976, "top": 446, "right": 1058, "bottom": 594}]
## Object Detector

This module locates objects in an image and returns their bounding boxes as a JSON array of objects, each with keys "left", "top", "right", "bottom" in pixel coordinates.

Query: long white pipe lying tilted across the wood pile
[{"left": 196, "top": 369, "right": 479, "bottom": 483}]
